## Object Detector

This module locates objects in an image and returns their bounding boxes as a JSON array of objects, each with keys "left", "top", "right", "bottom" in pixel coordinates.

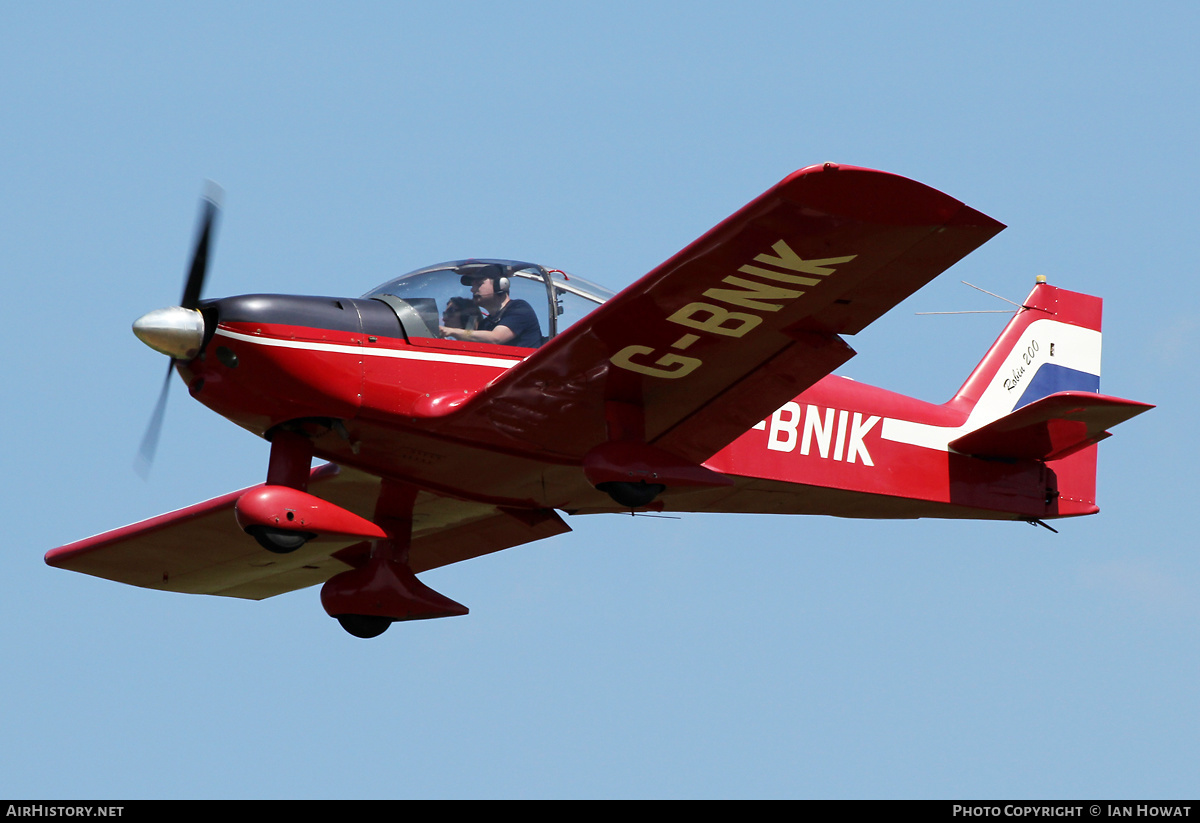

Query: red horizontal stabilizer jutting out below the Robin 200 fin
[{"left": 950, "top": 391, "right": 1154, "bottom": 461}]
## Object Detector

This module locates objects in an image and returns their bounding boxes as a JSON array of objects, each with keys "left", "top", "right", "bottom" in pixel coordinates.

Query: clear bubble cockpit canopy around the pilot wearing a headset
[{"left": 362, "top": 259, "right": 613, "bottom": 348}]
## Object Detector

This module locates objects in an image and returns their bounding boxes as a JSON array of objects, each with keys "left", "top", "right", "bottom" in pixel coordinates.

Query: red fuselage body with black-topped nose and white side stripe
[{"left": 180, "top": 295, "right": 1070, "bottom": 519}]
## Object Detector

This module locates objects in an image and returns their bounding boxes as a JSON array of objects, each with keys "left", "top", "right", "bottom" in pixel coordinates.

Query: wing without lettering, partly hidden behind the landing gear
[{"left": 46, "top": 464, "right": 570, "bottom": 600}]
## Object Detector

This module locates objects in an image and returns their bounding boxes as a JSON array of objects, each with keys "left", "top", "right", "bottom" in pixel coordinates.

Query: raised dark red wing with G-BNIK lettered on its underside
[{"left": 432, "top": 163, "right": 1004, "bottom": 462}]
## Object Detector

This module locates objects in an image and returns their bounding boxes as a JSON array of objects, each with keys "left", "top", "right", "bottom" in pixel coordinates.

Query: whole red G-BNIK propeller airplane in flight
[{"left": 46, "top": 163, "right": 1153, "bottom": 637}]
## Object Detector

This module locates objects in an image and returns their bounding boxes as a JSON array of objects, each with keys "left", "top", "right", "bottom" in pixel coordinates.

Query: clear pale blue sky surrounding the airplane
[{"left": 0, "top": 2, "right": 1200, "bottom": 798}]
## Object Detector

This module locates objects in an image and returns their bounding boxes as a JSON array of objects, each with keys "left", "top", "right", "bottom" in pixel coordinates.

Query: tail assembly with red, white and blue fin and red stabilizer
[{"left": 947, "top": 278, "right": 1153, "bottom": 517}]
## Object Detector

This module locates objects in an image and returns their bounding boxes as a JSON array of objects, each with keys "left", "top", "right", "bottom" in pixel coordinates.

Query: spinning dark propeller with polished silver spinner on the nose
[{"left": 133, "top": 181, "right": 222, "bottom": 479}]
